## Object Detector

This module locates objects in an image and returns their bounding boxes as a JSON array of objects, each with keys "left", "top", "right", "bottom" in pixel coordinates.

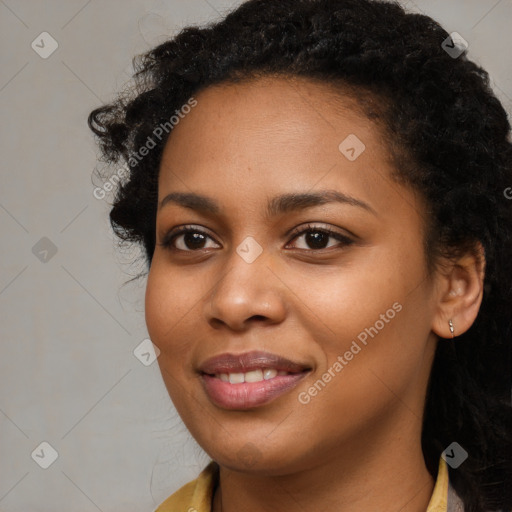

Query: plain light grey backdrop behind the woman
[{"left": 0, "top": 0, "right": 512, "bottom": 512}]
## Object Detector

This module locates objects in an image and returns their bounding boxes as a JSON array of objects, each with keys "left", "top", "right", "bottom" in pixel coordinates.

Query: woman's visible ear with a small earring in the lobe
[{"left": 432, "top": 242, "right": 485, "bottom": 338}]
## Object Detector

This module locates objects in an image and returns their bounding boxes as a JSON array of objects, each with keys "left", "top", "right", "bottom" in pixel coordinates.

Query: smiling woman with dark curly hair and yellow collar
[{"left": 89, "top": 0, "right": 512, "bottom": 512}]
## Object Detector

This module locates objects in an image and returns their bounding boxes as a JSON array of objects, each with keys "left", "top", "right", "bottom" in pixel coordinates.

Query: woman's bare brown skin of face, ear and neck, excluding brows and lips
[{"left": 146, "top": 78, "right": 483, "bottom": 512}]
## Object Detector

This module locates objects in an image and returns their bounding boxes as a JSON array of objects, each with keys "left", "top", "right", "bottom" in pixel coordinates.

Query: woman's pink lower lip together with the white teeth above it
[{"left": 202, "top": 371, "right": 309, "bottom": 410}]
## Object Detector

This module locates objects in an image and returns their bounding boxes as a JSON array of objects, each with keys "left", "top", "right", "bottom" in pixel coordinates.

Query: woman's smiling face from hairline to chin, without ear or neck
[{"left": 146, "top": 79, "right": 436, "bottom": 474}]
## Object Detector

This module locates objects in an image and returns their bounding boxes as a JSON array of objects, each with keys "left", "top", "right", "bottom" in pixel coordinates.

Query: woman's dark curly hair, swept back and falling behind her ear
[{"left": 88, "top": 0, "right": 512, "bottom": 512}]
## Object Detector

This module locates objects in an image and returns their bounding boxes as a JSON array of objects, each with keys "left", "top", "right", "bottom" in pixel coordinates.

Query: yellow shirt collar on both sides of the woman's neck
[{"left": 155, "top": 457, "right": 464, "bottom": 512}]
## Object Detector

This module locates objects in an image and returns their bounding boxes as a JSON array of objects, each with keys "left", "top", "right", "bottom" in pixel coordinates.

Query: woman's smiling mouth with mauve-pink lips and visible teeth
[{"left": 199, "top": 351, "right": 311, "bottom": 410}]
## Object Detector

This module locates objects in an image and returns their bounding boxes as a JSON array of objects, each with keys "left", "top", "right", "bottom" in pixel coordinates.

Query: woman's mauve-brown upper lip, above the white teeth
[{"left": 199, "top": 350, "right": 311, "bottom": 375}]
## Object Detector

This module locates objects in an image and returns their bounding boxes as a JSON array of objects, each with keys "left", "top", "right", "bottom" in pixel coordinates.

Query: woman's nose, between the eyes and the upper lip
[{"left": 204, "top": 252, "right": 286, "bottom": 331}]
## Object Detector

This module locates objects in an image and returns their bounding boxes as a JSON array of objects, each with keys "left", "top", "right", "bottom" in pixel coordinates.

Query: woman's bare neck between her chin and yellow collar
[{"left": 212, "top": 412, "right": 434, "bottom": 512}]
